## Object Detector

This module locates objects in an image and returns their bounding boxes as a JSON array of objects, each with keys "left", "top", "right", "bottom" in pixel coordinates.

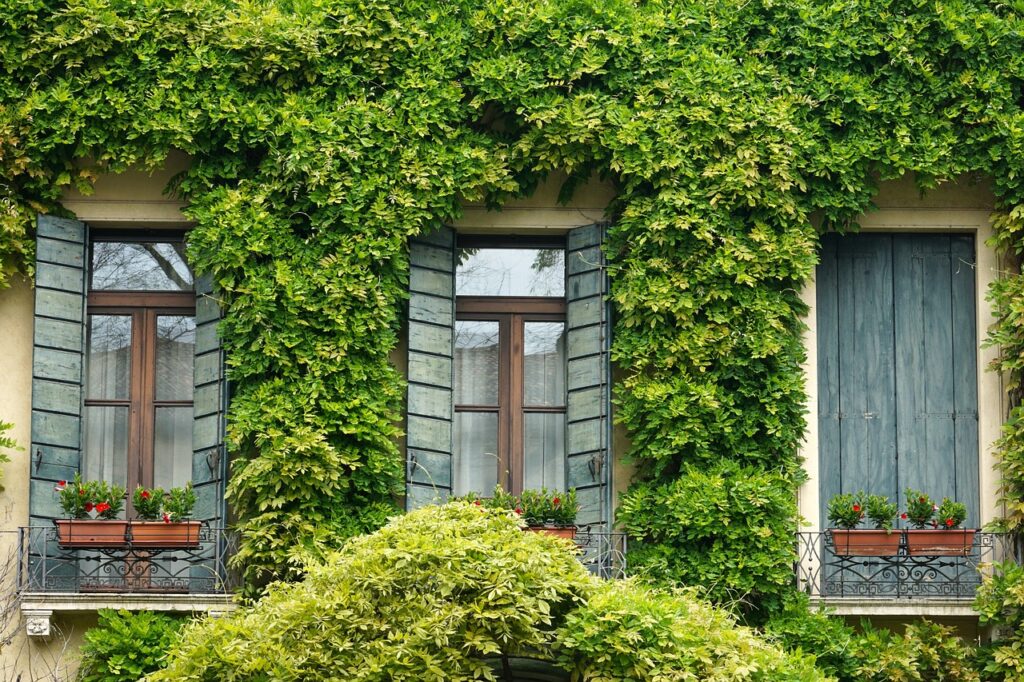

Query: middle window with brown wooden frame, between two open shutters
[{"left": 453, "top": 238, "right": 566, "bottom": 495}]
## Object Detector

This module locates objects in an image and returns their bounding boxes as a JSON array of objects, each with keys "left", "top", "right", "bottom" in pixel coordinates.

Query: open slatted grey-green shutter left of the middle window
[{"left": 406, "top": 227, "right": 455, "bottom": 509}]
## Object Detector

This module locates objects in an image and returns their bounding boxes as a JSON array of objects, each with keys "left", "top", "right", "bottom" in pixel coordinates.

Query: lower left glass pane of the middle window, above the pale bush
[{"left": 452, "top": 412, "right": 499, "bottom": 495}]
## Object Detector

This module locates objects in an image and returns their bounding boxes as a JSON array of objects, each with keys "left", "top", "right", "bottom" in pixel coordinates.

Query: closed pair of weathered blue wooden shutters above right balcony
[{"left": 816, "top": 235, "right": 979, "bottom": 526}]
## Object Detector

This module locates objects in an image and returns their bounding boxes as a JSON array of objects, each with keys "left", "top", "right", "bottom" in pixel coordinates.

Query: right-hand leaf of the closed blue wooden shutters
[{"left": 893, "top": 235, "right": 980, "bottom": 520}]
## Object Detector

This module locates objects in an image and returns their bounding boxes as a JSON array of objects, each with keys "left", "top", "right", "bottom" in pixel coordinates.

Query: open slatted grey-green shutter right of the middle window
[{"left": 565, "top": 224, "right": 611, "bottom": 525}]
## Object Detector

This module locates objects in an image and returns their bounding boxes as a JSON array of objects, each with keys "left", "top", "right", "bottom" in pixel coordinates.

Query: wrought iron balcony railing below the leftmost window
[{"left": 18, "top": 524, "right": 239, "bottom": 595}]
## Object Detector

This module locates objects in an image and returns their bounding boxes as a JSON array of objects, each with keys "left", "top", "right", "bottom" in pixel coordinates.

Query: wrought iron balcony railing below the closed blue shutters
[{"left": 796, "top": 530, "right": 1021, "bottom": 601}]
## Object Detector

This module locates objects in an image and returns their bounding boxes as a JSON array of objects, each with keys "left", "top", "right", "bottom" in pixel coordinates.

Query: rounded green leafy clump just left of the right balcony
[{"left": 618, "top": 461, "right": 797, "bottom": 607}]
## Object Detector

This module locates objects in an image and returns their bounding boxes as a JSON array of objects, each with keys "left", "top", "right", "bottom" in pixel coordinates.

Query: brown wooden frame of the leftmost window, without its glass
[{"left": 83, "top": 231, "right": 196, "bottom": 501}]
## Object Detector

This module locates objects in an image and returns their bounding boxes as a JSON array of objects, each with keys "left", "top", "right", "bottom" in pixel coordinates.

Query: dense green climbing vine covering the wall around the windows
[{"left": 0, "top": 0, "right": 1024, "bottom": 605}]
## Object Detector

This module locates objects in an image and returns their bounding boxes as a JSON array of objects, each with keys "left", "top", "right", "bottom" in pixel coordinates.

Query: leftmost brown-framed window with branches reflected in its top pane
[{"left": 82, "top": 232, "right": 196, "bottom": 503}]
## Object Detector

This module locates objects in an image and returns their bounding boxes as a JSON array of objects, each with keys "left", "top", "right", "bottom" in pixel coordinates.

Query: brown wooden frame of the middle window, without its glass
[{"left": 454, "top": 236, "right": 567, "bottom": 495}]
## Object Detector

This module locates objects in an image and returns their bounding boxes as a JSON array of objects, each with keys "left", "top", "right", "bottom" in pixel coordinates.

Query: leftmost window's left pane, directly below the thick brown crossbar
[{"left": 85, "top": 315, "right": 131, "bottom": 400}]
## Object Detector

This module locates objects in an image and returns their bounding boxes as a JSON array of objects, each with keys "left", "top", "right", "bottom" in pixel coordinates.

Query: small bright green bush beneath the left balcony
[{"left": 79, "top": 608, "right": 184, "bottom": 682}]
